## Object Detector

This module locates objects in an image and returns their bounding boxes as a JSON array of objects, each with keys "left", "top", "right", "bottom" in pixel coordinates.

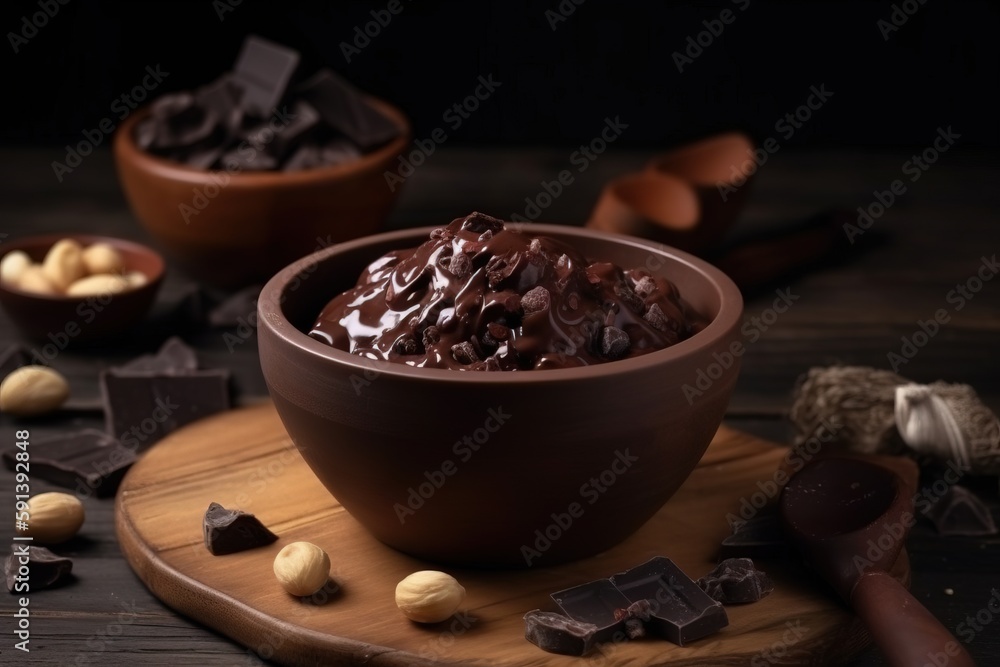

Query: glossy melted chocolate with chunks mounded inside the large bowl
[{"left": 309, "top": 213, "right": 703, "bottom": 370}]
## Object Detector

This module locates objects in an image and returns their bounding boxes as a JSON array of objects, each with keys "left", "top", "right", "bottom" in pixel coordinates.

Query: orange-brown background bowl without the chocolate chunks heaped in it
[{"left": 114, "top": 98, "right": 411, "bottom": 287}]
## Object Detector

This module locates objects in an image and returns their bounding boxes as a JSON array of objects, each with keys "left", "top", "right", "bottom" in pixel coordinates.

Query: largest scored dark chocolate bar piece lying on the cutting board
[{"left": 610, "top": 556, "right": 729, "bottom": 646}]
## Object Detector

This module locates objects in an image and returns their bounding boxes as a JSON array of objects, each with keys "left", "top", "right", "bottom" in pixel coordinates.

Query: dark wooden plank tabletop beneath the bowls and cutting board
[{"left": 0, "top": 147, "right": 1000, "bottom": 666}]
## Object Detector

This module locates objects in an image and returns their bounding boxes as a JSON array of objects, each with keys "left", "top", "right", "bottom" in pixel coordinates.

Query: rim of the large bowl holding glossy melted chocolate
[{"left": 257, "top": 223, "right": 743, "bottom": 385}]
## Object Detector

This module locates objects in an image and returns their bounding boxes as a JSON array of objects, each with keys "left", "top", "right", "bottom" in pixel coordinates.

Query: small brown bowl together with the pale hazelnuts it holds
[{"left": 0, "top": 234, "right": 165, "bottom": 350}]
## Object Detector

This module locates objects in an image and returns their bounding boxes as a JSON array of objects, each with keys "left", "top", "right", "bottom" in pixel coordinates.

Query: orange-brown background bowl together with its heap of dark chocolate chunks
[{"left": 113, "top": 37, "right": 411, "bottom": 287}]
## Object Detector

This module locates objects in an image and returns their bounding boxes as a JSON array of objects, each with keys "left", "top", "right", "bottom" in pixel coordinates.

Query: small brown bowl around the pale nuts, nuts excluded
[{"left": 0, "top": 233, "right": 165, "bottom": 348}]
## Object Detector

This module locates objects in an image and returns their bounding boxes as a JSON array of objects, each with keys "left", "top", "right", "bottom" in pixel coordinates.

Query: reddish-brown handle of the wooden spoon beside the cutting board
[{"left": 851, "top": 572, "right": 976, "bottom": 667}]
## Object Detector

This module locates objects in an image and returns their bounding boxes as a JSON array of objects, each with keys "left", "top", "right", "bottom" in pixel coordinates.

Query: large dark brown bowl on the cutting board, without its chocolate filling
[{"left": 258, "top": 225, "right": 743, "bottom": 568}]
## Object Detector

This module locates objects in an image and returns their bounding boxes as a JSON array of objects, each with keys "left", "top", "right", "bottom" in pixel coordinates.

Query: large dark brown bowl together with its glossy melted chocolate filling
[{"left": 258, "top": 213, "right": 742, "bottom": 568}]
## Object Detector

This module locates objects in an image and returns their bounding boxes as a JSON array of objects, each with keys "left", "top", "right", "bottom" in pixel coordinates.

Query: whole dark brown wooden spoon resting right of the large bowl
[{"left": 780, "top": 458, "right": 975, "bottom": 667}]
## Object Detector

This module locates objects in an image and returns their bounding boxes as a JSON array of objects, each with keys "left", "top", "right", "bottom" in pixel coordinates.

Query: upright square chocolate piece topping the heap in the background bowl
[{"left": 233, "top": 35, "right": 299, "bottom": 117}]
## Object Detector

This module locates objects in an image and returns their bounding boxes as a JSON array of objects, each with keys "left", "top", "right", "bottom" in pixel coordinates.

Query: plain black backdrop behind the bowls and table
[{"left": 0, "top": 0, "right": 1000, "bottom": 148}]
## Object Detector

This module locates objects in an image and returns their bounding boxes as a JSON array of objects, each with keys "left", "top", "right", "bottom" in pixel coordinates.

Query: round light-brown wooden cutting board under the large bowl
[{"left": 116, "top": 404, "right": 908, "bottom": 667}]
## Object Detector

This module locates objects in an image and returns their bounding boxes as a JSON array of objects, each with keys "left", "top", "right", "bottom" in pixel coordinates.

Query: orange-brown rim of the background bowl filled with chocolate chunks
[{"left": 112, "top": 95, "right": 412, "bottom": 188}]
